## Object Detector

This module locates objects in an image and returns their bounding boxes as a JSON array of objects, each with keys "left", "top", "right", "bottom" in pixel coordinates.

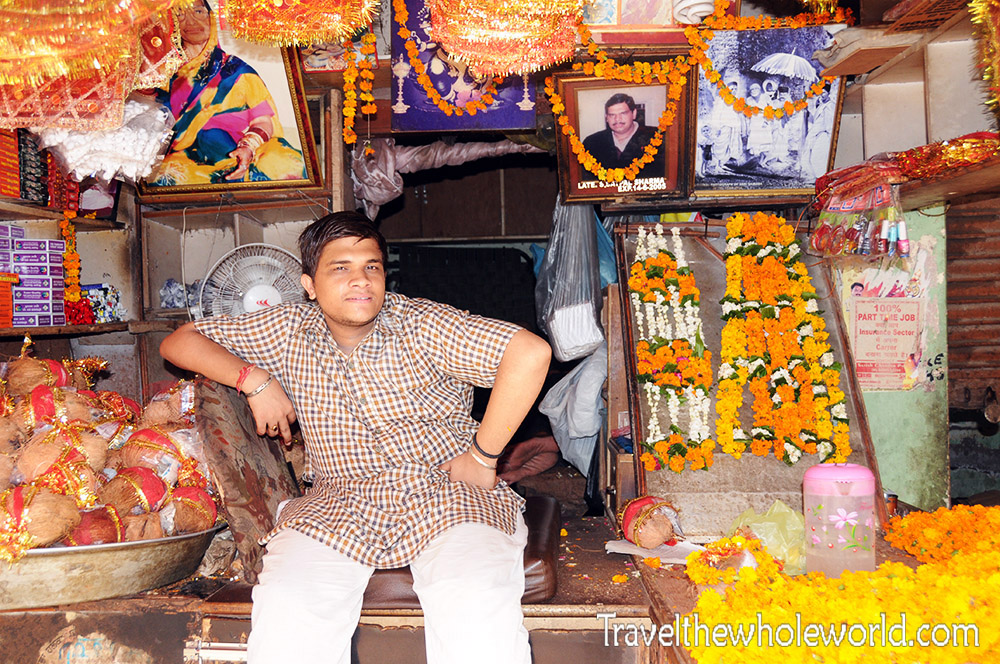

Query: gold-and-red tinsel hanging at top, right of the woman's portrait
[{"left": 221, "top": 0, "right": 378, "bottom": 46}]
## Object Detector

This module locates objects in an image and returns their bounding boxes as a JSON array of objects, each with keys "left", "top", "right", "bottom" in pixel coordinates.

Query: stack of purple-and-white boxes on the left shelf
[{"left": 11, "top": 233, "right": 66, "bottom": 327}]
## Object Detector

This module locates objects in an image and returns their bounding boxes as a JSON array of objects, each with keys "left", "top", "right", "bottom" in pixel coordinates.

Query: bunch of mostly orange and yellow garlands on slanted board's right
[{"left": 716, "top": 213, "right": 851, "bottom": 464}]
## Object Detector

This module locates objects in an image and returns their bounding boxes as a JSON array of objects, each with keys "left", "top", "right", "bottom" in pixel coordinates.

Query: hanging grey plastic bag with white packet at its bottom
[{"left": 535, "top": 198, "right": 604, "bottom": 360}]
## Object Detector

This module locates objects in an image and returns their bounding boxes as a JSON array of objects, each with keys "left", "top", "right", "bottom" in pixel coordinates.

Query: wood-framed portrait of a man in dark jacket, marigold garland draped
[{"left": 555, "top": 65, "right": 690, "bottom": 202}]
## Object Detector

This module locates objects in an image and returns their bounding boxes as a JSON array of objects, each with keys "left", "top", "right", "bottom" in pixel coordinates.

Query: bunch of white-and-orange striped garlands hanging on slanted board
[{"left": 628, "top": 224, "right": 715, "bottom": 473}]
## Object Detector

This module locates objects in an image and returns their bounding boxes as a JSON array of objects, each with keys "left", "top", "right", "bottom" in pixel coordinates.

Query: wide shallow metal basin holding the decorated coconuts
[{"left": 0, "top": 524, "right": 224, "bottom": 610}]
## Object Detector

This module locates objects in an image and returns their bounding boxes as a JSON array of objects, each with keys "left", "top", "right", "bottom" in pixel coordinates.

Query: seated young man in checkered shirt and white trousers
[{"left": 160, "top": 212, "right": 550, "bottom": 664}]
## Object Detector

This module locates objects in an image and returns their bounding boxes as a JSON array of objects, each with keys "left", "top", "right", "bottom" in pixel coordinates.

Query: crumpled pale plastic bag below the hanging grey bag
[{"left": 538, "top": 342, "right": 608, "bottom": 475}]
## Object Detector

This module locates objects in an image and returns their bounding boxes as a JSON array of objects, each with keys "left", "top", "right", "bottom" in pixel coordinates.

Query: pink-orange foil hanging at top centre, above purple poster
[{"left": 428, "top": 0, "right": 583, "bottom": 75}]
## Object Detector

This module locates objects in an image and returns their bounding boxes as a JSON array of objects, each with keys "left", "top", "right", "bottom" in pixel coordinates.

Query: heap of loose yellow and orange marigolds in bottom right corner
[{"left": 685, "top": 506, "right": 1000, "bottom": 664}]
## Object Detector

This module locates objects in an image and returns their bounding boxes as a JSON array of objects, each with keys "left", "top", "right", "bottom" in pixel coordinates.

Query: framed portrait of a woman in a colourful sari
[{"left": 139, "top": 0, "right": 322, "bottom": 202}]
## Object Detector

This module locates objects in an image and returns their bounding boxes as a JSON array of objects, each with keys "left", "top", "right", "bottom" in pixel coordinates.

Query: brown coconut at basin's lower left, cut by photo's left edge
[{"left": 0, "top": 485, "right": 80, "bottom": 561}]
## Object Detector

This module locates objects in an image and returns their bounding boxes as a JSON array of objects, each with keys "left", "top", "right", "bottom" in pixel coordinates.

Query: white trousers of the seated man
[{"left": 248, "top": 518, "right": 531, "bottom": 664}]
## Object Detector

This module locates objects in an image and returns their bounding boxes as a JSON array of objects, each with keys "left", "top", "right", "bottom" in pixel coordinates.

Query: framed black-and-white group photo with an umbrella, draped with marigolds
[{"left": 693, "top": 26, "right": 843, "bottom": 200}]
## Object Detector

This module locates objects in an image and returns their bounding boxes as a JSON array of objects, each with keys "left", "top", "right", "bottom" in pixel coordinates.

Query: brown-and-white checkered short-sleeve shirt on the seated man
[{"left": 195, "top": 293, "right": 524, "bottom": 568}]
